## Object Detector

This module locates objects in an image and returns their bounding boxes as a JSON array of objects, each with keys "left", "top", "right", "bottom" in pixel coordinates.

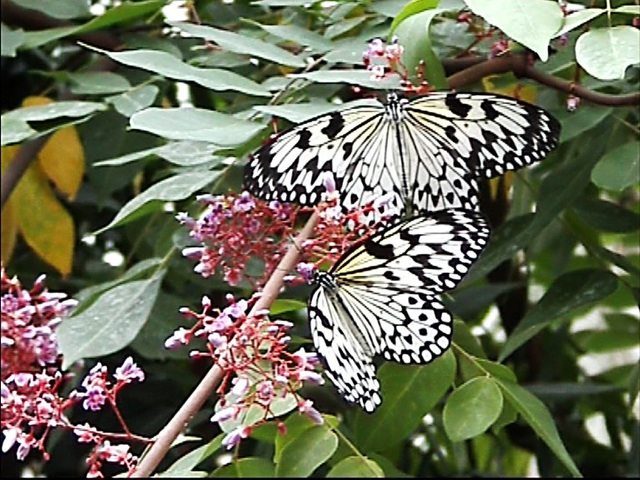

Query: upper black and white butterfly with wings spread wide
[{"left": 244, "top": 92, "right": 560, "bottom": 213}]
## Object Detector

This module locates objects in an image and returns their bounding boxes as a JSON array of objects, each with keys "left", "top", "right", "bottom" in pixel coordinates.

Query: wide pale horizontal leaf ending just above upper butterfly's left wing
[{"left": 129, "top": 107, "right": 264, "bottom": 147}]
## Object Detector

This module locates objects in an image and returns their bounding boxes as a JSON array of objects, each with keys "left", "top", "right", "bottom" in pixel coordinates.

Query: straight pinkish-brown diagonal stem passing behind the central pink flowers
[{"left": 131, "top": 213, "right": 318, "bottom": 477}]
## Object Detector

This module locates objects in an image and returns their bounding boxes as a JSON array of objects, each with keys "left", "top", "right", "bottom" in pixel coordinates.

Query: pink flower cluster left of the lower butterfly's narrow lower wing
[{"left": 165, "top": 295, "right": 324, "bottom": 448}]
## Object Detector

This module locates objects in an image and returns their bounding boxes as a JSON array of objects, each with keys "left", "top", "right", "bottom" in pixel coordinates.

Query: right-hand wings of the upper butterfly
[{"left": 403, "top": 92, "right": 560, "bottom": 211}]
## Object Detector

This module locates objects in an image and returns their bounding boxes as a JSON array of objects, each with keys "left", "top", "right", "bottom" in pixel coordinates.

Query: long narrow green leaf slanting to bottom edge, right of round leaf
[{"left": 496, "top": 378, "right": 582, "bottom": 477}]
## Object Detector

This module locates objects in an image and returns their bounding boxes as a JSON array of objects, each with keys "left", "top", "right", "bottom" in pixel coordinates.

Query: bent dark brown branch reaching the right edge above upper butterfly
[{"left": 447, "top": 55, "right": 640, "bottom": 107}]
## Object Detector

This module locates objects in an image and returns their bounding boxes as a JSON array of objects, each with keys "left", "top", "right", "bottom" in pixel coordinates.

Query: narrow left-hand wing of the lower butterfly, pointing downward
[{"left": 308, "top": 285, "right": 382, "bottom": 412}]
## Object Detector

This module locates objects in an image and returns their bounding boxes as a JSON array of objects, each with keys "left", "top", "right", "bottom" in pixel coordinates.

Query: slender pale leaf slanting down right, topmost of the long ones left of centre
[{"left": 168, "top": 22, "right": 306, "bottom": 68}]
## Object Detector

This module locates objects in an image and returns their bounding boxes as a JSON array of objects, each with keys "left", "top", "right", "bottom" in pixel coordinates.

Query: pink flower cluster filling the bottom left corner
[{"left": 0, "top": 267, "right": 150, "bottom": 477}]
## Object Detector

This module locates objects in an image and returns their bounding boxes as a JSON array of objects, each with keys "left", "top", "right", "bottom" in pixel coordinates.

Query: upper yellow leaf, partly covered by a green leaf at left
[{"left": 22, "top": 97, "right": 85, "bottom": 200}]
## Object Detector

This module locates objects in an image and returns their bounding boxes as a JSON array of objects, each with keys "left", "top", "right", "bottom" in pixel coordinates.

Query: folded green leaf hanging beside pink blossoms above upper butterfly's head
[{"left": 394, "top": 9, "right": 447, "bottom": 90}]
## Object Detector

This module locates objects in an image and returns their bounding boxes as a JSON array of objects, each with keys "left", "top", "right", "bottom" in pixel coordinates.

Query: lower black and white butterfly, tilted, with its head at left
[{"left": 308, "top": 209, "right": 490, "bottom": 412}]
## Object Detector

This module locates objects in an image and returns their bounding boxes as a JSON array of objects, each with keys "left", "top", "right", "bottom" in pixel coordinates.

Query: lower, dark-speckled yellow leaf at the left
[{"left": 11, "top": 159, "right": 75, "bottom": 276}]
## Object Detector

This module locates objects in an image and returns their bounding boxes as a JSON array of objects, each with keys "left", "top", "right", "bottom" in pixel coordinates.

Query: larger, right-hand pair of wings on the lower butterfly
[{"left": 330, "top": 209, "right": 490, "bottom": 363}]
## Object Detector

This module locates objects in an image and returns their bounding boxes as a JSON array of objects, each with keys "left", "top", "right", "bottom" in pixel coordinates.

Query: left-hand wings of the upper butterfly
[{"left": 244, "top": 102, "right": 404, "bottom": 209}]
